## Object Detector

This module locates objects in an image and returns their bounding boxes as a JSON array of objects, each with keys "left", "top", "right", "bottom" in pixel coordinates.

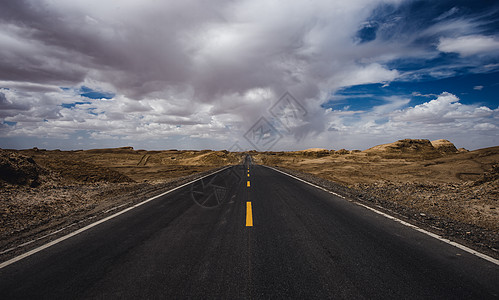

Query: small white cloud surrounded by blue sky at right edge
[{"left": 437, "top": 35, "right": 499, "bottom": 56}]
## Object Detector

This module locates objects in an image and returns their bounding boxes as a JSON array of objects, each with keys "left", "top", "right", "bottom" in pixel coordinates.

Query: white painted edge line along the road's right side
[{"left": 262, "top": 165, "right": 499, "bottom": 266}]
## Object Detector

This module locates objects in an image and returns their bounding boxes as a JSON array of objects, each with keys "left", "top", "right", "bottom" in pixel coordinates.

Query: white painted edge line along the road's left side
[{"left": 0, "top": 166, "right": 232, "bottom": 269}]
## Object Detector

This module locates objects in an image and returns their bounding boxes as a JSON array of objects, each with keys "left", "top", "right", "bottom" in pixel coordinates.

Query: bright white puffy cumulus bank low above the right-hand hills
[{"left": 316, "top": 92, "right": 499, "bottom": 148}]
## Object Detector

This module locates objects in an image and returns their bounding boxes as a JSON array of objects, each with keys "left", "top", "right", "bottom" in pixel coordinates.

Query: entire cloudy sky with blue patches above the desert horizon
[{"left": 0, "top": 0, "right": 499, "bottom": 151}]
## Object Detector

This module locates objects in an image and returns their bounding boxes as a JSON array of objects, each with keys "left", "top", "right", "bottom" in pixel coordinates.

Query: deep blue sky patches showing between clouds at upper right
[{"left": 323, "top": 1, "right": 499, "bottom": 117}]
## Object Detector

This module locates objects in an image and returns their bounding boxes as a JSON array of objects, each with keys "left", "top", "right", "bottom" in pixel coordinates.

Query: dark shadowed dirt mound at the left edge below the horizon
[{"left": 0, "top": 150, "right": 46, "bottom": 187}]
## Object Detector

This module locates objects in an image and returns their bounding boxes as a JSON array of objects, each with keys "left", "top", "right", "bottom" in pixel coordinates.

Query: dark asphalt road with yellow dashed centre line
[{"left": 0, "top": 159, "right": 499, "bottom": 299}]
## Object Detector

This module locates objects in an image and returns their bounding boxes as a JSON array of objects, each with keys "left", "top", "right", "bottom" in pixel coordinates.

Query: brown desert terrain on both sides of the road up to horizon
[{"left": 0, "top": 139, "right": 499, "bottom": 257}]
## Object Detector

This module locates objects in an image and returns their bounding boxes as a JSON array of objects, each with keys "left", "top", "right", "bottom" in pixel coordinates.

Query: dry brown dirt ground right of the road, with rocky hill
[{"left": 254, "top": 140, "right": 499, "bottom": 257}]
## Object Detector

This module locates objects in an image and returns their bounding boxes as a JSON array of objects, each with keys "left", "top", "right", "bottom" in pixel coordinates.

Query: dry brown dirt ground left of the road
[{"left": 0, "top": 147, "right": 242, "bottom": 256}]
